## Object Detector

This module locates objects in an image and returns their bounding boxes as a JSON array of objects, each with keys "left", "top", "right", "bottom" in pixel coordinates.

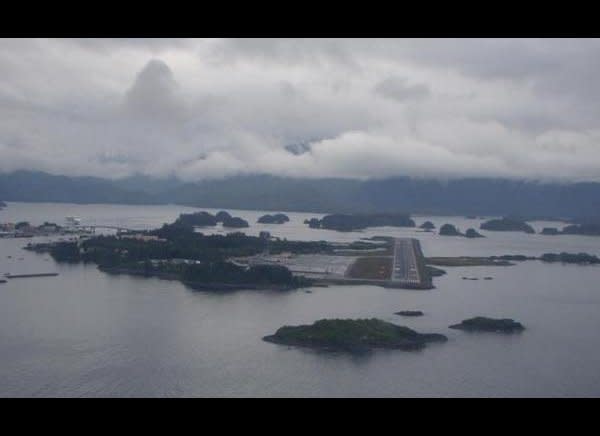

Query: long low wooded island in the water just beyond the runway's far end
[{"left": 304, "top": 213, "right": 415, "bottom": 232}]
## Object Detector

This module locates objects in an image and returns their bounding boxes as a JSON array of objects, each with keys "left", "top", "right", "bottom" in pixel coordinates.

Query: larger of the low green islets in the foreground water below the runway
[{"left": 263, "top": 318, "right": 448, "bottom": 352}]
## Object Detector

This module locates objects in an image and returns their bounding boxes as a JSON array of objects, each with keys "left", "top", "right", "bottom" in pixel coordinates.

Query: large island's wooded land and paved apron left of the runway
[{"left": 22, "top": 212, "right": 410, "bottom": 290}]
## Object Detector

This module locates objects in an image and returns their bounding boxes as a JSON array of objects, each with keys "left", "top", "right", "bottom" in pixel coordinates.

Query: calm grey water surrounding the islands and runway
[{"left": 0, "top": 203, "right": 600, "bottom": 397}]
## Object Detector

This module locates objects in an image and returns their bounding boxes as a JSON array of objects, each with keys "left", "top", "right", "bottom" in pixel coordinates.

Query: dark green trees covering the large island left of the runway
[{"left": 39, "top": 212, "right": 410, "bottom": 288}]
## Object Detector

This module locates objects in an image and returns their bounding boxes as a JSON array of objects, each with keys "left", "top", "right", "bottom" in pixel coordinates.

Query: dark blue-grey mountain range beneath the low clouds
[{"left": 0, "top": 171, "right": 600, "bottom": 219}]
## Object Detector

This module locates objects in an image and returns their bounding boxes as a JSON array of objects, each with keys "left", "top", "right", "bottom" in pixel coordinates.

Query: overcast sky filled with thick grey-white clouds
[{"left": 0, "top": 39, "right": 600, "bottom": 182}]
